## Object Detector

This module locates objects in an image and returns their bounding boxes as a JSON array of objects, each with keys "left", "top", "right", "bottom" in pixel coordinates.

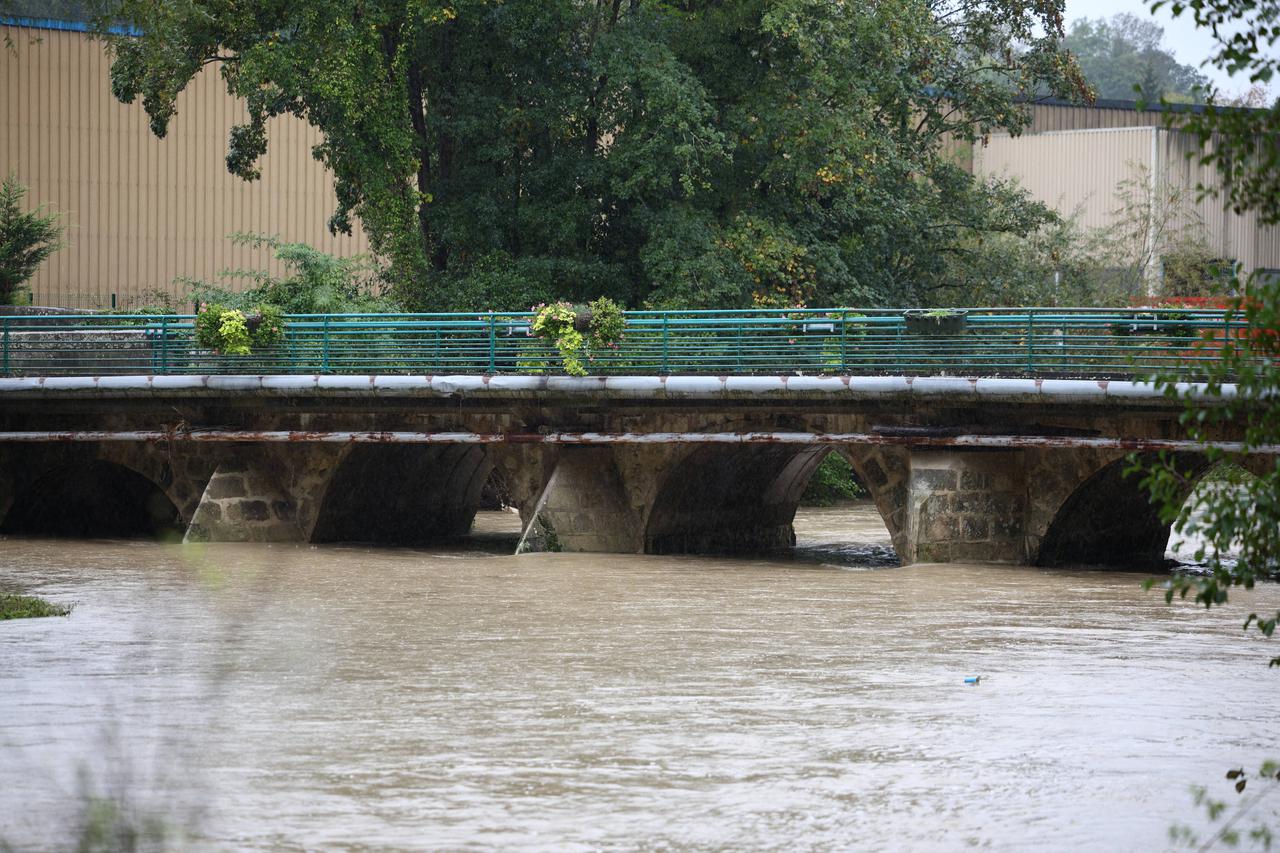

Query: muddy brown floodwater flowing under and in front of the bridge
[{"left": 0, "top": 505, "right": 1280, "bottom": 850}]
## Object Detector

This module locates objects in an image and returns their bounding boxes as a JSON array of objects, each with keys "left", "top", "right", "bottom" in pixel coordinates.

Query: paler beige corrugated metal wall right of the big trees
[{"left": 974, "top": 127, "right": 1280, "bottom": 273}]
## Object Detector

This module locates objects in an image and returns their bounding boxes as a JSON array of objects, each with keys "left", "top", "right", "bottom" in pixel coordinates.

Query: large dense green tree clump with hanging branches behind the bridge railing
[{"left": 99, "top": 0, "right": 1087, "bottom": 309}]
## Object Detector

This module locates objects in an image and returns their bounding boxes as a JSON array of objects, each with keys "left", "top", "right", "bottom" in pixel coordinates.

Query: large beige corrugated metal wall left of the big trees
[{"left": 0, "top": 27, "right": 367, "bottom": 307}]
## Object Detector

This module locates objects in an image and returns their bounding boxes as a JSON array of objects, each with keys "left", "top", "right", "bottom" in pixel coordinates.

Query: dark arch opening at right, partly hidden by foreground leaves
[{"left": 1036, "top": 453, "right": 1208, "bottom": 571}]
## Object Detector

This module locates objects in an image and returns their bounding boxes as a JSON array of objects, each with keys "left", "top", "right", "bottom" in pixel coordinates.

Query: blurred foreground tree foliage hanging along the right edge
[{"left": 1143, "top": 0, "right": 1280, "bottom": 835}]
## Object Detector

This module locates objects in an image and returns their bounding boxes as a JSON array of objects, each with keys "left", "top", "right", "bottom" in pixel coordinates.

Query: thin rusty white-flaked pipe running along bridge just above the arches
[{"left": 0, "top": 429, "right": 1280, "bottom": 456}]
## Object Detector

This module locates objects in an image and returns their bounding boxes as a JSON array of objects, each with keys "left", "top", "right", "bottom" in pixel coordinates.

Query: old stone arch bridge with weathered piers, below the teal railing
[{"left": 0, "top": 375, "right": 1274, "bottom": 565}]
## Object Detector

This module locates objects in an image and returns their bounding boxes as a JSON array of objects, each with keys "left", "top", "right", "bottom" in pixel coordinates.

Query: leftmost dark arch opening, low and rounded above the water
[{"left": 0, "top": 460, "right": 183, "bottom": 539}]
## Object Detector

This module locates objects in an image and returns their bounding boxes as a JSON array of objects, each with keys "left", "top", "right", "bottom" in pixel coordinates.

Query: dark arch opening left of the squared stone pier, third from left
[{"left": 644, "top": 444, "right": 827, "bottom": 553}]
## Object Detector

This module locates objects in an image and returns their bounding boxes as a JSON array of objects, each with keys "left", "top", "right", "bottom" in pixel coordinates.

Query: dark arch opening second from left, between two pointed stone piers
[{"left": 311, "top": 444, "right": 493, "bottom": 544}]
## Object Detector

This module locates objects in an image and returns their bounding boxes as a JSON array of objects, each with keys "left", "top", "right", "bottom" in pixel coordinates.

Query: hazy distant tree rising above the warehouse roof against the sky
[{"left": 1066, "top": 13, "right": 1208, "bottom": 101}]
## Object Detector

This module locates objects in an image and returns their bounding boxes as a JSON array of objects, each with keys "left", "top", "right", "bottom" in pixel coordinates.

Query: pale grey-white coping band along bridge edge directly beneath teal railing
[{"left": 0, "top": 374, "right": 1236, "bottom": 405}]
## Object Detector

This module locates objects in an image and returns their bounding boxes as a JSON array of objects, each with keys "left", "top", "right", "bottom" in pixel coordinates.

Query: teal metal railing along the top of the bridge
[{"left": 0, "top": 307, "right": 1244, "bottom": 378}]
